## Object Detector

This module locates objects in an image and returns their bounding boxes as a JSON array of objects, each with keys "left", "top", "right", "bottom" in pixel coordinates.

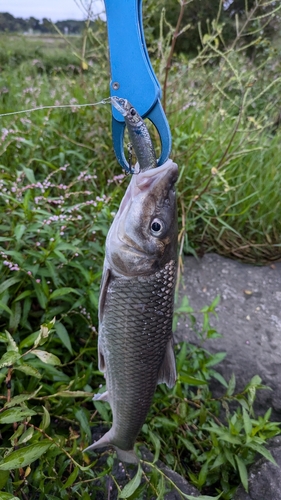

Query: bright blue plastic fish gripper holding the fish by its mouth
[{"left": 105, "top": 0, "right": 172, "bottom": 171}]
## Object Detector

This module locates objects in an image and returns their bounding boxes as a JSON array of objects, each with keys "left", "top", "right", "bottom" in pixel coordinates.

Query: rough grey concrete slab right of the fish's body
[{"left": 176, "top": 254, "right": 281, "bottom": 420}]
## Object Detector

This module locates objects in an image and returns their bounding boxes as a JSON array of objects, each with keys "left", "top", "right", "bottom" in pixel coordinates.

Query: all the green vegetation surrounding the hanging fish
[{"left": 0, "top": 0, "right": 281, "bottom": 500}]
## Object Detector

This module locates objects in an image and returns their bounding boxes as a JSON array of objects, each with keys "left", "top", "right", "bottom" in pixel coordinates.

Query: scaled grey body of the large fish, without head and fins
[{"left": 100, "top": 261, "right": 175, "bottom": 450}]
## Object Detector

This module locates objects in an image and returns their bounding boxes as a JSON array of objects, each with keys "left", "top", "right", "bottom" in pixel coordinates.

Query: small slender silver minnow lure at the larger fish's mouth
[{"left": 110, "top": 96, "right": 157, "bottom": 172}]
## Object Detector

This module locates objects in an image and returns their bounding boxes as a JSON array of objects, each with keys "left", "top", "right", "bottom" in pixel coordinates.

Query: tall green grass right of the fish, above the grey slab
[{"left": 164, "top": 52, "right": 281, "bottom": 263}]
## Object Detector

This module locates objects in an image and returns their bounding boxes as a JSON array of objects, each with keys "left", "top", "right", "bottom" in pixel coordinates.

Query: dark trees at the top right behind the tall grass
[{"left": 147, "top": 0, "right": 281, "bottom": 54}]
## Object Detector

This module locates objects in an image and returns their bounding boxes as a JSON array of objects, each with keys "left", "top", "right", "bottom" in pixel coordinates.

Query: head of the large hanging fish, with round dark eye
[{"left": 106, "top": 160, "right": 178, "bottom": 277}]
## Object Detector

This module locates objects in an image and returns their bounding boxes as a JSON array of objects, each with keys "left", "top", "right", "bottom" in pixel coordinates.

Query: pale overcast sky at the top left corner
[{"left": 0, "top": 0, "right": 104, "bottom": 22}]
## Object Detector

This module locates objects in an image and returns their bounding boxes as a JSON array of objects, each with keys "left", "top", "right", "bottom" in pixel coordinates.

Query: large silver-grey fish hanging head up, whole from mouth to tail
[{"left": 85, "top": 160, "right": 178, "bottom": 463}]
